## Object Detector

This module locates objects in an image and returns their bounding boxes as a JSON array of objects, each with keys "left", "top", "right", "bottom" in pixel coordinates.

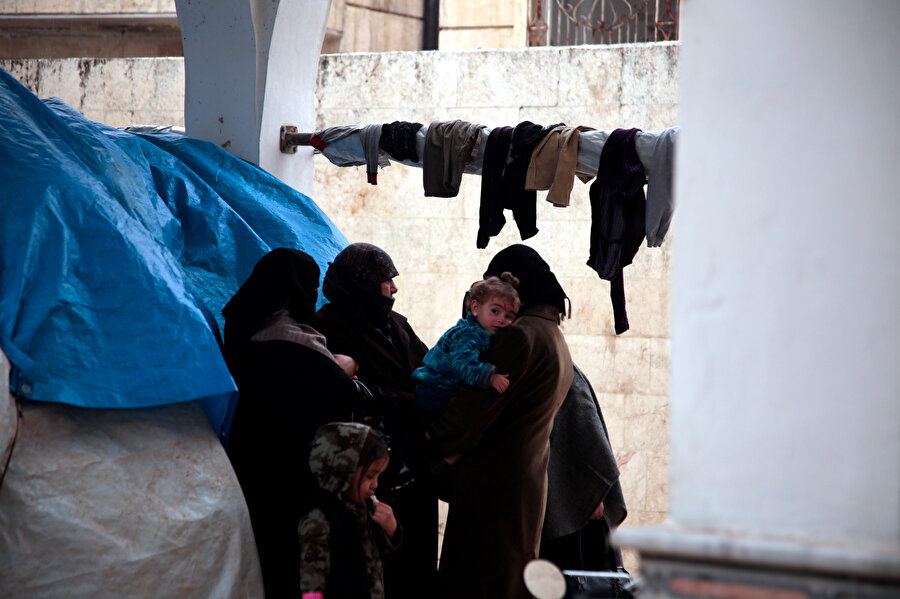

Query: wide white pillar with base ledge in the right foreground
[{"left": 617, "top": 0, "right": 900, "bottom": 596}]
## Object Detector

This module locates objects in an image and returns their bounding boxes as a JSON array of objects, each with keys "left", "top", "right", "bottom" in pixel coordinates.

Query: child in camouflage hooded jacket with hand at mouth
[{"left": 297, "top": 422, "right": 401, "bottom": 599}]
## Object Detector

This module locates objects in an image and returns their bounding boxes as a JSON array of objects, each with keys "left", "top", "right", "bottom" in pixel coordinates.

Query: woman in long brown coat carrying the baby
[{"left": 431, "top": 245, "right": 573, "bottom": 599}]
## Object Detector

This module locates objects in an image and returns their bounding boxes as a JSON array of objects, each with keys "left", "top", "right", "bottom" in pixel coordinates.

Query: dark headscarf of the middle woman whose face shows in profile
[{"left": 322, "top": 243, "right": 399, "bottom": 329}]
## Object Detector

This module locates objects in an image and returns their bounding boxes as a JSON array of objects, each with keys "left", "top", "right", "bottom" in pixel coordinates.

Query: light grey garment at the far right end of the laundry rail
[{"left": 646, "top": 127, "right": 681, "bottom": 247}]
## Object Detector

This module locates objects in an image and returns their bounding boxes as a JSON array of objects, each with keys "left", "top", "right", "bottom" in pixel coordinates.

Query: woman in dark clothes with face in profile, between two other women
[{"left": 316, "top": 243, "right": 438, "bottom": 599}]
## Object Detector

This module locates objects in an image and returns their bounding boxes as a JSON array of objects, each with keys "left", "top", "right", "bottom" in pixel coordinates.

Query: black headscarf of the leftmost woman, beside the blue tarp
[{"left": 222, "top": 248, "right": 319, "bottom": 348}]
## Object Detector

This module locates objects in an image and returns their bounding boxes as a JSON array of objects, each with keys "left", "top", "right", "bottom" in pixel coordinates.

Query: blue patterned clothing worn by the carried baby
[{"left": 412, "top": 312, "right": 497, "bottom": 415}]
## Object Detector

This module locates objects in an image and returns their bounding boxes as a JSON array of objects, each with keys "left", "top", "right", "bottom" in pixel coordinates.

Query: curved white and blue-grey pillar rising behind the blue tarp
[{"left": 176, "top": 0, "right": 331, "bottom": 195}]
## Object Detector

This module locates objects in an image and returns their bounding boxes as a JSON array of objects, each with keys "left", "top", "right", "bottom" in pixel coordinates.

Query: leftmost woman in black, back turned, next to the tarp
[{"left": 222, "top": 248, "right": 357, "bottom": 597}]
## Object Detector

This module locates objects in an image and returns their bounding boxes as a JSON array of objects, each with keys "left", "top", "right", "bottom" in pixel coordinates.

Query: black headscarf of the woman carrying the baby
[{"left": 484, "top": 244, "right": 568, "bottom": 314}]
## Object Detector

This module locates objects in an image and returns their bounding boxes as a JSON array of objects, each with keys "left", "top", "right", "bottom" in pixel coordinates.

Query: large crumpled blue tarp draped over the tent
[{"left": 0, "top": 69, "right": 347, "bottom": 440}]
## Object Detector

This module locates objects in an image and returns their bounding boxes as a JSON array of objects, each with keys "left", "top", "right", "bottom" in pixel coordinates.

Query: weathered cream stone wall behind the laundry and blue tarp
[{"left": 0, "top": 44, "right": 678, "bottom": 568}]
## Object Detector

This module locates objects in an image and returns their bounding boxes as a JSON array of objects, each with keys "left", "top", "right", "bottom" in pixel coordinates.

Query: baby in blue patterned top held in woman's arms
[{"left": 412, "top": 272, "right": 521, "bottom": 421}]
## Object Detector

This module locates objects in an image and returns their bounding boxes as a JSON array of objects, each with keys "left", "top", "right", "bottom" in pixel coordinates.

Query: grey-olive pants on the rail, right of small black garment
[{"left": 422, "top": 120, "right": 485, "bottom": 198}]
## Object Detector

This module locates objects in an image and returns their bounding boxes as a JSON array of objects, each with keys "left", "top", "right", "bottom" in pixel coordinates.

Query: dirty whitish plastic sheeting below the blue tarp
[{"left": 0, "top": 353, "right": 263, "bottom": 599}]
